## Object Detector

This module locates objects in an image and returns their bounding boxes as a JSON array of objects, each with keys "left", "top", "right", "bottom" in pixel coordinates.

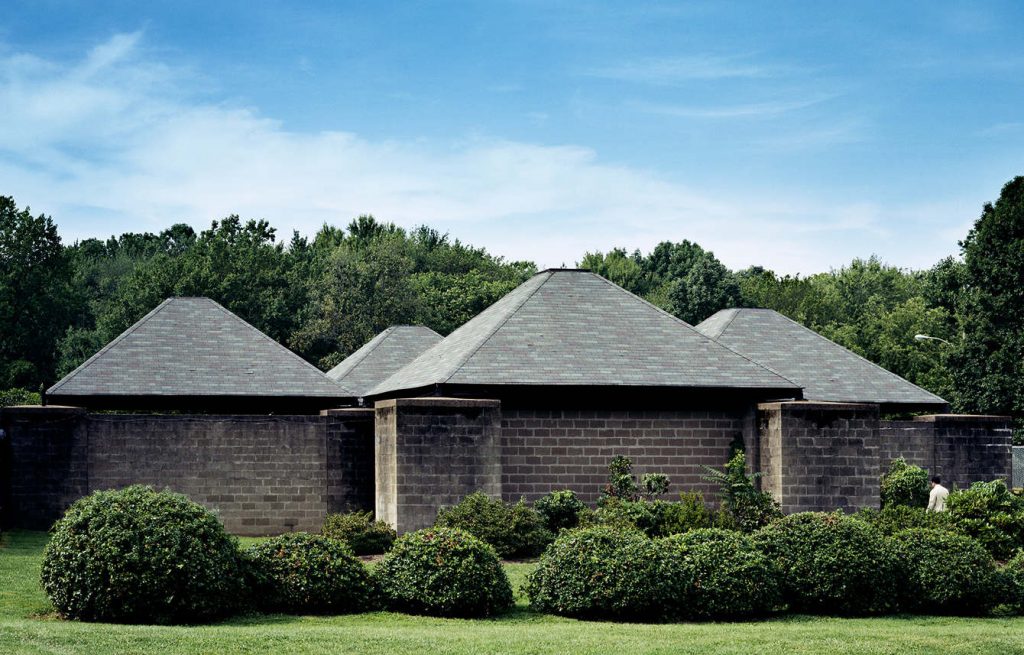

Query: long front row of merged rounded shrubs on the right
[{"left": 526, "top": 513, "right": 1011, "bottom": 620}]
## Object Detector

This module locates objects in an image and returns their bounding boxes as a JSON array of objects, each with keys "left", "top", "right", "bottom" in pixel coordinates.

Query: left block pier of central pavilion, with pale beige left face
[{"left": 374, "top": 398, "right": 502, "bottom": 532}]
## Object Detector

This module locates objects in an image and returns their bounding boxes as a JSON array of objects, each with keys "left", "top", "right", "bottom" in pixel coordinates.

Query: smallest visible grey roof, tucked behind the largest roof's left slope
[{"left": 327, "top": 325, "right": 442, "bottom": 396}]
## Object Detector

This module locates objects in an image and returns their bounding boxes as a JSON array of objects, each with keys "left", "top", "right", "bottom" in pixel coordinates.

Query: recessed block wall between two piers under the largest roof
[{"left": 501, "top": 408, "right": 753, "bottom": 503}]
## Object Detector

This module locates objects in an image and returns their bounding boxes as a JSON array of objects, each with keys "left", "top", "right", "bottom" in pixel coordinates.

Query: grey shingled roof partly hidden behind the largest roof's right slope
[{"left": 696, "top": 309, "right": 947, "bottom": 407}]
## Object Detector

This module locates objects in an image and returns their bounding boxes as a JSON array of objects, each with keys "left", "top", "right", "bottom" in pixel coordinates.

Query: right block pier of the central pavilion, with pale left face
[{"left": 758, "top": 401, "right": 881, "bottom": 514}]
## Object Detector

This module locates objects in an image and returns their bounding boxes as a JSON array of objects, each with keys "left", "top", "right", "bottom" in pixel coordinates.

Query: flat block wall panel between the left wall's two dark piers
[{"left": 88, "top": 414, "right": 328, "bottom": 534}]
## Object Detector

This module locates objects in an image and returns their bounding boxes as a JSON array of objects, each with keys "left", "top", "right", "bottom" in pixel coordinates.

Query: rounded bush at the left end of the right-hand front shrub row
[{"left": 526, "top": 526, "right": 669, "bottom": 620}]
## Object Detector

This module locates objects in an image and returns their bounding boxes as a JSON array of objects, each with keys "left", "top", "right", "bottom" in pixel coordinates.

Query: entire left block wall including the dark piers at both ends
[{"left": 0, "top": 407, "right": 373, "bottom": 535}]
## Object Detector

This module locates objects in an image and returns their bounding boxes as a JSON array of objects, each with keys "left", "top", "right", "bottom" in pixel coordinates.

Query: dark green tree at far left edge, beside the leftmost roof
[{"left": 0, "top": 197, "right": 82, "bottom": 389}]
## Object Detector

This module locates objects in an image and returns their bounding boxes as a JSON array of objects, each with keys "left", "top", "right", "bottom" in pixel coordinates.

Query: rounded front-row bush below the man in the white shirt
[{"left": 893, "top": 528, "right": 999, "bottom": 614}]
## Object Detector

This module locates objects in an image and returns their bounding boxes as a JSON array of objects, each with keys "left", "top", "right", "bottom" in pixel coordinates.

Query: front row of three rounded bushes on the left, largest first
[{"left": 41, "top": 486, "right": 512, "bottom": 623}]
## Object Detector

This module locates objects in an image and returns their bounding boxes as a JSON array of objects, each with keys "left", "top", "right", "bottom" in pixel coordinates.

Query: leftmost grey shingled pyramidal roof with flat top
[{"left": 47, "top": 298, "right": 353, "bottom": 398}]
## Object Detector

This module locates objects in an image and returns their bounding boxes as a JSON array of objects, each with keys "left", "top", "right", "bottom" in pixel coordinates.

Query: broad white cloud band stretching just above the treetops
[{"left": 0, "top": 34, "right": 959, "bottom": 273}]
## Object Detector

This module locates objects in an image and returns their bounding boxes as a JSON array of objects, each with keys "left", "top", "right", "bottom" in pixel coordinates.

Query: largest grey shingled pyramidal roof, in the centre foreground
[{"left": 369, "top": 269, "right": 799, "bottom": 397}]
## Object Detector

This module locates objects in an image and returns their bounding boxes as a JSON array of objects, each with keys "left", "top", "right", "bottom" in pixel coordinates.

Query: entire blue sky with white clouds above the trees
[{"left": 0, "top": 0, "right": 1024, "bottom": 274}]
